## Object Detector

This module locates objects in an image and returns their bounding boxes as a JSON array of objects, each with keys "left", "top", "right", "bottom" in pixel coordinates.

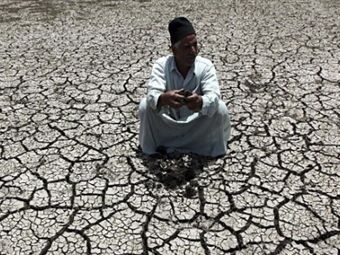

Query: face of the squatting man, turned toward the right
[{"left": 172, "top": 34, "right": 198, "bottom": 67}]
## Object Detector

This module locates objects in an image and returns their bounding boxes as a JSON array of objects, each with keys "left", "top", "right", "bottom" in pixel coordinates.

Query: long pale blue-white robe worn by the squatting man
[{"left": 139, "top": 55, "right": 230, "bottom": 157}]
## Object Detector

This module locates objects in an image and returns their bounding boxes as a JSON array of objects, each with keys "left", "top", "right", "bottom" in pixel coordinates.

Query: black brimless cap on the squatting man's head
[{"left": 168, "top": 17, "right": 196, "bottom": 45}]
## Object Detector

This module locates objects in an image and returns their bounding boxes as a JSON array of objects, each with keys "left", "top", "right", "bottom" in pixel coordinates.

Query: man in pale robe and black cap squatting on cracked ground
[{"left": 139, "top": 17, "right": 230, "bottom": 157}]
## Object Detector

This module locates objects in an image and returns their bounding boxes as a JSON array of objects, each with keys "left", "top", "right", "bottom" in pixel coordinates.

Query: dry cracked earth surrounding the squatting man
[{"left": 0, "top": 0, "right": 340, "bottom": 255}]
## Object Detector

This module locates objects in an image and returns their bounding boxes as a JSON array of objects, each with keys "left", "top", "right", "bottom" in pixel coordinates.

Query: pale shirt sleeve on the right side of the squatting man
[{"left": 201, "top": 64, "right": 220, "bottom": 116}]
